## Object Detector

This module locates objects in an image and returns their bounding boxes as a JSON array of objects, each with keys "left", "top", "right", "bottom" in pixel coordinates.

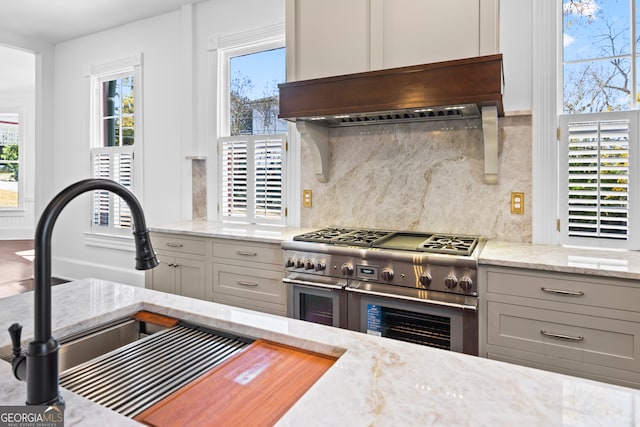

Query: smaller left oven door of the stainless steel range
[{"left": 282, "top": 273, "right": 347, "bottom": 329}]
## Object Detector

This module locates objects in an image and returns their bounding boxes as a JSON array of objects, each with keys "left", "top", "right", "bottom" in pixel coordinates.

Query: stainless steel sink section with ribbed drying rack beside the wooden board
[{"left": 59, "top": 319, "right": 253, "bottom": 417}]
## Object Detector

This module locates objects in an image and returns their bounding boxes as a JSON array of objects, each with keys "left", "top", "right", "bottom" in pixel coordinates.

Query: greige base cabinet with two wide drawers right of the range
[{"left": 479, "top": 266, "right": 640, "bottom": 387}]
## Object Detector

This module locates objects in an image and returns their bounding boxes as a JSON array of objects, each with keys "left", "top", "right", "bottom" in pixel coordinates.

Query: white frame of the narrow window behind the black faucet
[{"left": 86, "top": 54, "right": 144, "bottom": 239}]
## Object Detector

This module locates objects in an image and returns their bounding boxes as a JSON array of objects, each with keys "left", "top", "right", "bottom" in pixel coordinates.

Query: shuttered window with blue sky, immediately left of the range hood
[{"left": 217, "top": 27, "right": 288, "bottom": 224}]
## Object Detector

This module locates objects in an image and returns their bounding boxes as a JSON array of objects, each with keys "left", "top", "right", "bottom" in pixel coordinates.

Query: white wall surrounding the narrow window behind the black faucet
[{"left": 53, "top": 0, "right": 284, "bottom": 286}]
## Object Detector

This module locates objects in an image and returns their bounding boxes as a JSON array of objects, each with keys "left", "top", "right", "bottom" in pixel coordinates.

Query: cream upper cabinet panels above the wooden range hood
[{"left": 287, "top": 0, "right": 499, "bottom": 81}]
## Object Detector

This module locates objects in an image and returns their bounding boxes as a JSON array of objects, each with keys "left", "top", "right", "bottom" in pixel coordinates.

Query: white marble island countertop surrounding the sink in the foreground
[{"left": 0, "top": 279, "right": 640, "bottom": 427}]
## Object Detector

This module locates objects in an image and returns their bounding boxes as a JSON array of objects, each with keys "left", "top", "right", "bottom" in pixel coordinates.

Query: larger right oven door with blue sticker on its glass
[{"left": 346, "top": 281, "right": 478, "bottom": 355}]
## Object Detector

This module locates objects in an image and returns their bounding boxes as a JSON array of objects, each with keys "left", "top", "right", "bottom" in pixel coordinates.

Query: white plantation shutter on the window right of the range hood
[{"left": 560, "top": 112, "right": 637, "bottom": 247}]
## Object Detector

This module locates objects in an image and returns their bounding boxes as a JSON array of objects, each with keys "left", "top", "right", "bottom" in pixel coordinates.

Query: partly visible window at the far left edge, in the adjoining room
[{"left": 0, "top": 112, "right": 21, "bottom": 209}]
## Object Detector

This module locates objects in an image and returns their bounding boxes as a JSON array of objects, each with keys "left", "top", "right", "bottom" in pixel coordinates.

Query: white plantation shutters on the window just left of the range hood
[{"left": 219, "top": 135, "right": 286, "bottom": 223}]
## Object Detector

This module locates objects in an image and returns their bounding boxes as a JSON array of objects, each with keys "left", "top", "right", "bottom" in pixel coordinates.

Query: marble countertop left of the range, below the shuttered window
[{"left": 149, "top": 221, "right": 314, "bottom": 243}]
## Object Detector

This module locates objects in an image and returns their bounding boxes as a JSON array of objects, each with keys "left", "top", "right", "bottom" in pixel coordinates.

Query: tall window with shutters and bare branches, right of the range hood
[{"left": 558, "top": 0, "right": 640, "bottom": 249}]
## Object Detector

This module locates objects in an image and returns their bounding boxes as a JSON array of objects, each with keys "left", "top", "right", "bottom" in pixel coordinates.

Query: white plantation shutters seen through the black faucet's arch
[{"left": 91, "top": 146, "right": 133, "bottom": 234}]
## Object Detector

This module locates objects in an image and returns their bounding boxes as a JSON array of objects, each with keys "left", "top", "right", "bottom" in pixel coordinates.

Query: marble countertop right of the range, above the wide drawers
[{"left": 478, "top": 240, "right": 640, "bottom": 280}]
